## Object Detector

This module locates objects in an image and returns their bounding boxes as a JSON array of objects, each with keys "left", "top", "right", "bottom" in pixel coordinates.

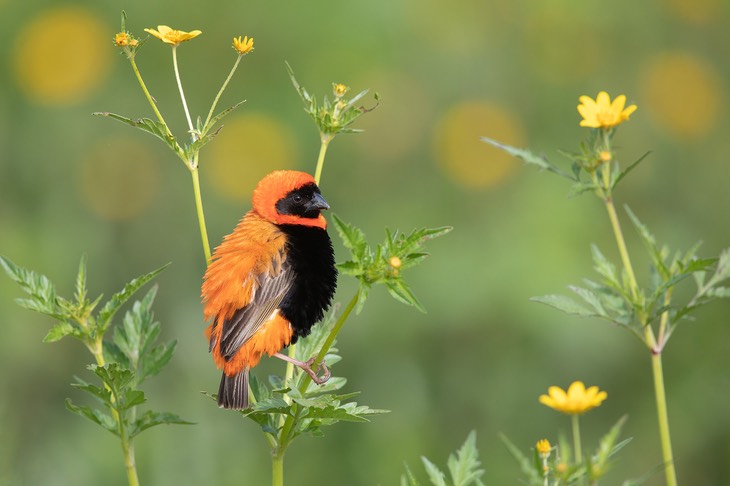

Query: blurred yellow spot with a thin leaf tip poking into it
[{"left": 435, "top": 101, "right": 525, "bottom": 188}]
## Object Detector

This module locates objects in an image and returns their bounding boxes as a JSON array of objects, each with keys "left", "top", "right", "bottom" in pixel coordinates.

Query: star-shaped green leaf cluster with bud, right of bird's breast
[{"left": 332, "top": 215, "right": 452, "bottom": 313}]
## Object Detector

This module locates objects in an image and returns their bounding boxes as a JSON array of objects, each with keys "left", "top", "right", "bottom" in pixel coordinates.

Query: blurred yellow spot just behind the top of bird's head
[{"left": 206, "top": 113, "right": 296, "bottom": 201}]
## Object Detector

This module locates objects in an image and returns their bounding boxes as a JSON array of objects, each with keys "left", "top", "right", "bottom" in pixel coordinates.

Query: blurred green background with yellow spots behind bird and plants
[{"left": 0, "top": 0, "right": 730, "bottom": 485}]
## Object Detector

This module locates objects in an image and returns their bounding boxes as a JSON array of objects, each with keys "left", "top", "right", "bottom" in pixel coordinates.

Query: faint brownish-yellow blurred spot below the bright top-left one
[{"left": 80, "top": 136, "right": 160, "bottom": 221}]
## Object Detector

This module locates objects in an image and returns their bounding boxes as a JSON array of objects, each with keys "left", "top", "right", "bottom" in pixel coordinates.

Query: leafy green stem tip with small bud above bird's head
[{"left": 286, "top": 63, "right": 380, "bottom": 140}]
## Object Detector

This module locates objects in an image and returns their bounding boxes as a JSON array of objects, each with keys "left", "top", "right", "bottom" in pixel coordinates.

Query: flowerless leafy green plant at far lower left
[{"left": 0, "top": 257, "right": 190, "bottom": 482}]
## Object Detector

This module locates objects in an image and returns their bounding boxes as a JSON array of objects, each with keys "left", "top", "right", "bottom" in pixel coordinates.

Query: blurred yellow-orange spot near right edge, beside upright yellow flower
[{"left": 639, "top": 53, "right": 723, "bottom": 139}]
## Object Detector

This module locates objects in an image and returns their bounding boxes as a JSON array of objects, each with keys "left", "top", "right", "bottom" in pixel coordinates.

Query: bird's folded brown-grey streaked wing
[{"left": 219, "top": 262, "right": 294, "bottom": 358}]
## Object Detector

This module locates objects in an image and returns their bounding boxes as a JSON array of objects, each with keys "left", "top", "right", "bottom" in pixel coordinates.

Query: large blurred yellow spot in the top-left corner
[{"left": 13, "top": 6, "right": 114, "bottom": 104}]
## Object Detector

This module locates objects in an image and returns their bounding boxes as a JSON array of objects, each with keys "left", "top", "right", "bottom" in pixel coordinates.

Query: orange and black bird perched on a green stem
[{"left": 201, "top": 170, "right": 337, "bottom": 410}]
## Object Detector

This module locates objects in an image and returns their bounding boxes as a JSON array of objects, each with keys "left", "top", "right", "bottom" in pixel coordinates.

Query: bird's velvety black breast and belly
[{"left": 279, "top": 225, "right": 337, "bottom": 343}]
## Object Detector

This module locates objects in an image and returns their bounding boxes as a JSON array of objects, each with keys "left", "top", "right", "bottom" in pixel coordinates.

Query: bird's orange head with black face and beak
[{"left": 252, "top": 170, "right": 330, "bottom": 229}]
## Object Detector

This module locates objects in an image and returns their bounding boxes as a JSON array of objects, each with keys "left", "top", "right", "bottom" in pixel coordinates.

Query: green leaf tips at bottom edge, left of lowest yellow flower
[{"left": 400, "top": 431, "right": 484, "bottom": 486}]
